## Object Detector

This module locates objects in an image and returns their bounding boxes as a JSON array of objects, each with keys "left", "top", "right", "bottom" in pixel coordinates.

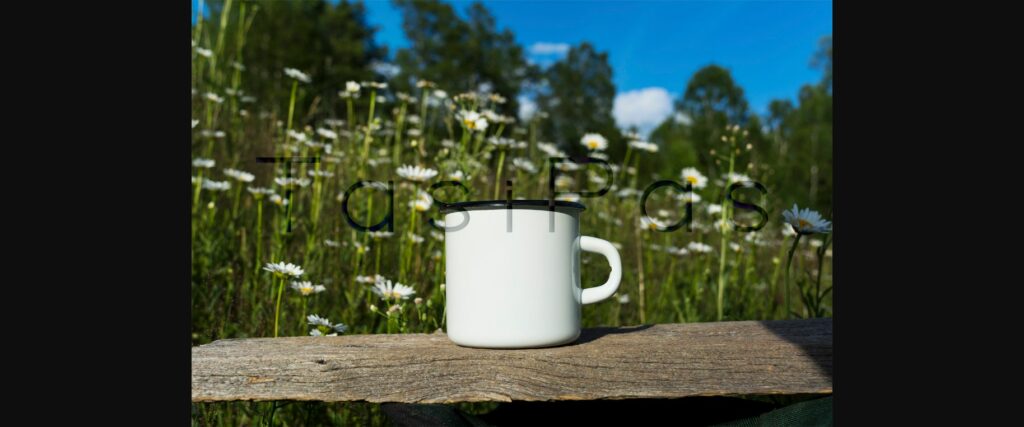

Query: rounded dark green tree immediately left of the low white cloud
[{"left": 538, "top": 43, "right": 626, "bottom": 159}]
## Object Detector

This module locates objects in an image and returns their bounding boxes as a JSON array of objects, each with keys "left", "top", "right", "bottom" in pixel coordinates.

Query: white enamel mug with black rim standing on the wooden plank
[{"left": 442, "top": 200, "right": 623, "bottom": 348}]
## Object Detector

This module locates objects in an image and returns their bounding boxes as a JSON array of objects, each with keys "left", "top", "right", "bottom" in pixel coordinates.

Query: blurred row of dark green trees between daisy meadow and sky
[{"left": 194, "top": 0, "right": 831, "bottom": 209}]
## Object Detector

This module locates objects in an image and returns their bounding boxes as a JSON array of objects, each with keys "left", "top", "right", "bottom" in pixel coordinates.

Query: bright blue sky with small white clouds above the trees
[{"left": 194, "top": 0, "right": 833, "bottom": 130}]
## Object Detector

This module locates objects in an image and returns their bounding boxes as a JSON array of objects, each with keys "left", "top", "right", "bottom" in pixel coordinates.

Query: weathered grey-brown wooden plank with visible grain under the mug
[{"left": 191, "top": 318, "right": 833, "bottom": 403}]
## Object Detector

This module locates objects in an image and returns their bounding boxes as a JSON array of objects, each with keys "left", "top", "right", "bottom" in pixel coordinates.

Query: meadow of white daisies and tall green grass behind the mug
[{"left": 190, "top": 1, "right": 833, "bottom": 425}]
